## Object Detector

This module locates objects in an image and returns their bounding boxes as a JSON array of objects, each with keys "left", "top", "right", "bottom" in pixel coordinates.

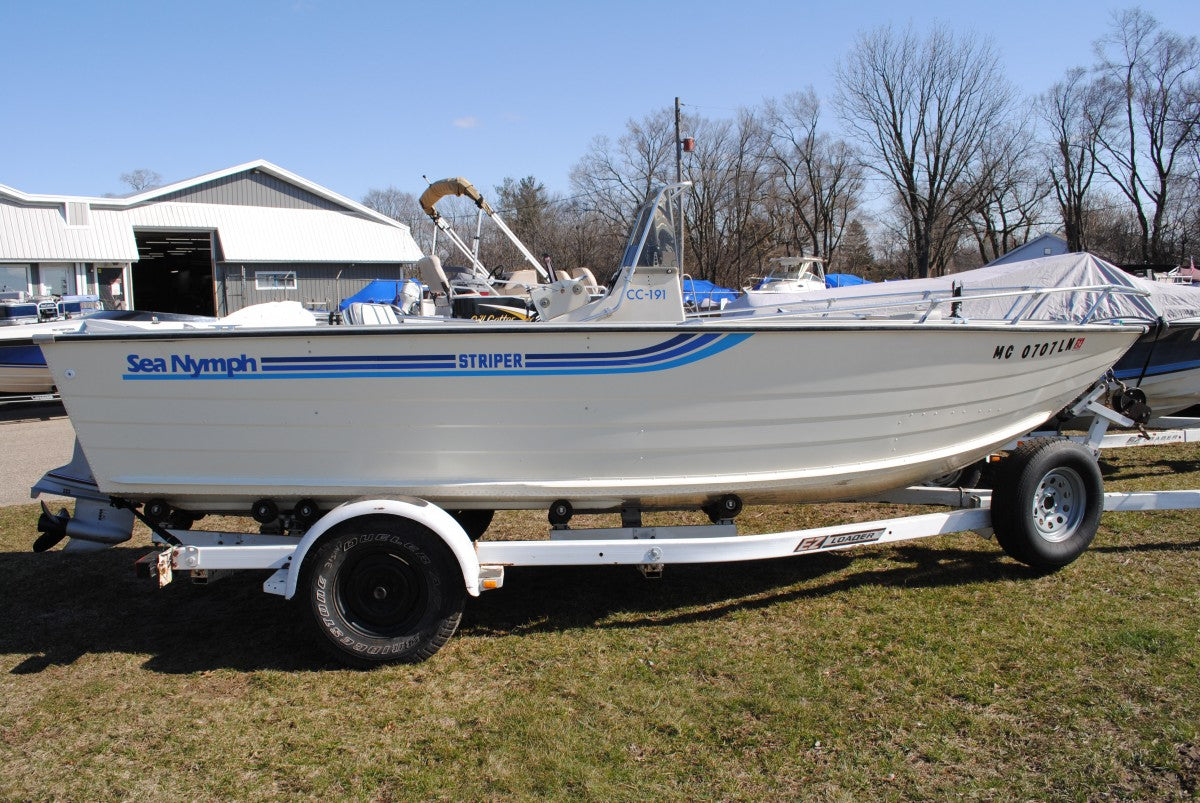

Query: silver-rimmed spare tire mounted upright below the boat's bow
[{"left": 991, "top": 438, "right": 1104, "bottom": 570}]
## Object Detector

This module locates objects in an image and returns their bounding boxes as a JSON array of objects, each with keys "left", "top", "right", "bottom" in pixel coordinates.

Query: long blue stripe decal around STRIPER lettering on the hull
[{"left": 121, "top": 332, "right": 752, "bottom": 382}]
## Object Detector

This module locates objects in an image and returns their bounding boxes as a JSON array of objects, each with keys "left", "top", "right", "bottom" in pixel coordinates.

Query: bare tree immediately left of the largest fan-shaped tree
[{"left": 766, "top": 89, "right": 864, "bottom": 259}]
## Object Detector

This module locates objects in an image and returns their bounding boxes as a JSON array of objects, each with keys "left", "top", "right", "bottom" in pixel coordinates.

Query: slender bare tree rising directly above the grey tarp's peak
[{"left": 1038, "top": 67, "right": 1108, "bottom": 251}]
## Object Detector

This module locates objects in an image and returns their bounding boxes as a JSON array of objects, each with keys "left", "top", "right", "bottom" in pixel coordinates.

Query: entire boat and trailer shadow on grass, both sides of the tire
[{"left": 0, "top": 535, "right": 1051, "bottom": 675}]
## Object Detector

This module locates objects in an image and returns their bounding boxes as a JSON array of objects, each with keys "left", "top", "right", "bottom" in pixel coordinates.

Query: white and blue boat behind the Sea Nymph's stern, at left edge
[{"left": 0, "top": 301, "right": 316, "bottom": 396}]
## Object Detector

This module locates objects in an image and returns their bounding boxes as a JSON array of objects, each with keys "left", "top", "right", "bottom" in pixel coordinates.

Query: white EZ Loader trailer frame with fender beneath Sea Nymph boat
[{"left": 129, "top": 487, "right": 1200, "bottom": 599}]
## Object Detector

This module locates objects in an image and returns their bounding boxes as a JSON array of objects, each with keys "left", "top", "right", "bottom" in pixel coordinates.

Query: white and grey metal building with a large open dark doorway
[{"left": 0, "top": 160, "right": 421, "bottom": 316}]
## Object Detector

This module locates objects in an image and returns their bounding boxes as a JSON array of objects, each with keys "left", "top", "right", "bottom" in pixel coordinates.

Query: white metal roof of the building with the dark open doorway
[{"left": 0, "top": 160, "right": 421, "bottom": 263}]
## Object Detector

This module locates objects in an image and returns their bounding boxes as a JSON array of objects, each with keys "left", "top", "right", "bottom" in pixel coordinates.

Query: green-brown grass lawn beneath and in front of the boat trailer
[{"left": 0, "top": 444, "right": 1200, "bottom": 801}]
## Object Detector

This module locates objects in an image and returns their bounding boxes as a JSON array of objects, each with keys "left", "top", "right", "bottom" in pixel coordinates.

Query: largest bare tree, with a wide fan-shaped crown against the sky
[{"left": 838, "top": 28, "right": 1014, "bottom": 276}]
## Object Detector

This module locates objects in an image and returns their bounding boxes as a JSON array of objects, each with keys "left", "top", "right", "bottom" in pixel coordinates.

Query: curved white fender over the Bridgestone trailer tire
[{"left": 283, "top": 498, "right": 479, "bottom": 599}]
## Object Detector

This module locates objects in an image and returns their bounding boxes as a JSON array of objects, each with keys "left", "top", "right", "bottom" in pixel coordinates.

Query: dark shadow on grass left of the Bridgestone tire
[{"left": 0, "top": 547, "right": 332, "bottom": 675}]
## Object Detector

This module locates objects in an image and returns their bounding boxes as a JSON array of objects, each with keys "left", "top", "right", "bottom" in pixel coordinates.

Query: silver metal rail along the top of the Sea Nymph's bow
[{"left": 739, "top": 284, "right": 1153, "bottom": 324}]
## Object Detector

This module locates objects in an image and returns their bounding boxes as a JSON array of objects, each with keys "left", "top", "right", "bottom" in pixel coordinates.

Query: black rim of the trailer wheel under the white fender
[{"left": 335, "top": 547, "right": 428, "bottom": 639}]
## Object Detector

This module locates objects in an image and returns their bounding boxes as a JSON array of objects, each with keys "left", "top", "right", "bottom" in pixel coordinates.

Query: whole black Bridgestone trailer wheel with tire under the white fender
[{"left": 302, "top": 516, "right": 466, "bottom": 669}]
